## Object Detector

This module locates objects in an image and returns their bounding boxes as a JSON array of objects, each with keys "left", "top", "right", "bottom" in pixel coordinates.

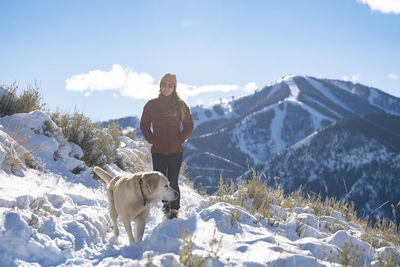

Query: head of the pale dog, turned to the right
[{"left": 142, "top": 171, "right": 179, "bottom": 202}]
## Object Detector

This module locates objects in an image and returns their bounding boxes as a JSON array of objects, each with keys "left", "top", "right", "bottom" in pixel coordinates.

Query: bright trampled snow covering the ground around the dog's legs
[{"left": 0, "top": 110, "right": 400, "bottom": 266}]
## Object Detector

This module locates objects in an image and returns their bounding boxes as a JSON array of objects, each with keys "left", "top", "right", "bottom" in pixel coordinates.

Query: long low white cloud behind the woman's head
[{"left": 66, "top": 64, "right": 239, "bottom": 99}]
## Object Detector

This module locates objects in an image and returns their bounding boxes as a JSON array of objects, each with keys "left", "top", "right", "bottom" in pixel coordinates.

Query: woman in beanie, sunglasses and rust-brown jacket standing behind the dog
[{"left": 140, "top": 73, "right": 193, "bottom": 219}]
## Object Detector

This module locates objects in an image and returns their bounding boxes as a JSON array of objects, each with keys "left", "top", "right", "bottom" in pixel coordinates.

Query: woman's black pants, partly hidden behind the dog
[{"left": 151, "top": 153, "right": 183, "bottom": 210}]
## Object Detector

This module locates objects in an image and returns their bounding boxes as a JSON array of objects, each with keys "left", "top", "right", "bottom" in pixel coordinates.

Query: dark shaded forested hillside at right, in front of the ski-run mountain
[{"left": 265, "top": 114, "right": 400, "bottom": 223}]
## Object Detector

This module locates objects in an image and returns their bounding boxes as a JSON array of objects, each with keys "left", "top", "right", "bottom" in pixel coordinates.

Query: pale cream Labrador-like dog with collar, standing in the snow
[{"left": 93, "top": 166, "right": 178, "bottom": 246}]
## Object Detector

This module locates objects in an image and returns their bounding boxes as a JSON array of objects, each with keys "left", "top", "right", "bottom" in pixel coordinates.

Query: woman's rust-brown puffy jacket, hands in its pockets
[{"left": 140, "top": 95, "right": 193, "bottom": 154}]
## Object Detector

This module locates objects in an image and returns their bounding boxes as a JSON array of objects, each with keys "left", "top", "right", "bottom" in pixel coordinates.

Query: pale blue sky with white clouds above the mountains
[{"left": 0, "top": 0, "right": 400, "bottom": 121}]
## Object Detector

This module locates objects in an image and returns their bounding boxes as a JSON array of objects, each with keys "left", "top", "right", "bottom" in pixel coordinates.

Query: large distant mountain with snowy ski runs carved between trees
[{"left": 185, "top": 76, "right": 400, "bottom": 192}]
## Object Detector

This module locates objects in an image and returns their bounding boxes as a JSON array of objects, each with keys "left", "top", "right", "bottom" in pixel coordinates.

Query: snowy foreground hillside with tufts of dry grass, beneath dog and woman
[{"left": 0, "top": 111, "right": 400, "bottom": 266}]
